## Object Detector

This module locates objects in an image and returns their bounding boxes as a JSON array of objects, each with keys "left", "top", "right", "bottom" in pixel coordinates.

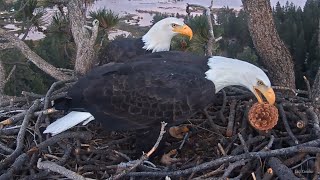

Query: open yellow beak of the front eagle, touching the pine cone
[{"left": 253, "top": 85, "right": 276, "bottom": 105}]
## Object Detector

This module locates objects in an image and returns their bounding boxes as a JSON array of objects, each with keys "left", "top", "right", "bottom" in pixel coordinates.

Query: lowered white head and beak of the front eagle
[{"left": 205, "top": 56, "right": 276, "bottom": 104}]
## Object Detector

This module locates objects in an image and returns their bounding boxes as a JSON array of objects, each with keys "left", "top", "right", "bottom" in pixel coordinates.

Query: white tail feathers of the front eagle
[{"left": 43, "top": 111, "right": 94, "bottom": 136}]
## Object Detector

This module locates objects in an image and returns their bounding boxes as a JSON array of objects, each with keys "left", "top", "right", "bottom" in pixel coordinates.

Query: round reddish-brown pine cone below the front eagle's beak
[{"left": 248, "top": 103, "right": 279, "bottom": 131}]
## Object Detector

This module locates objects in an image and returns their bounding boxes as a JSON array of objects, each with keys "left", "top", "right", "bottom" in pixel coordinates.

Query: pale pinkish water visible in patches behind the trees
[{"left": 1, "top": 0, "right": 306, "bottom": 40}]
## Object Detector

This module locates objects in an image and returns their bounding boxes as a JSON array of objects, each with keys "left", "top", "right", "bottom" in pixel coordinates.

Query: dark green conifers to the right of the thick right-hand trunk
[{"left": 273, "top": 0, "right": 320, "bottom": 88}]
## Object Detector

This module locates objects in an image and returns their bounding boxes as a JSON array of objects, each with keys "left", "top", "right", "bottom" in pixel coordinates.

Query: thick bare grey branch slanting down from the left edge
[{"left": 0, "top": 28, "right": 70, "bottom": 80}]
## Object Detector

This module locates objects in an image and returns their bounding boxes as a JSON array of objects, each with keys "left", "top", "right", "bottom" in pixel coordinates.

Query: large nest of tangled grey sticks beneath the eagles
[{"left": 0, "top": 82, "right": 320, "bottom": 180}]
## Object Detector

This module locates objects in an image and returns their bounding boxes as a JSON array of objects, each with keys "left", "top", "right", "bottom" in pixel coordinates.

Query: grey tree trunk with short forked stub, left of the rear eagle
[{"left": 68, "top": 0, "right": 99, "bottom": 75}]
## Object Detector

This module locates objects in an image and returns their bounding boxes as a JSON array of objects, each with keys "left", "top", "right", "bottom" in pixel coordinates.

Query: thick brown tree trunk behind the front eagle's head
[{"left": 242, "top": 0, "right": 295, "bottom": 88}]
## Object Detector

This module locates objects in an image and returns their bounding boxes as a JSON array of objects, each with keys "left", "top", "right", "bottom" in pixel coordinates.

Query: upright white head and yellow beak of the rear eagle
[{"left": 142, "top": 17, "right": 193, "bottom": 52}]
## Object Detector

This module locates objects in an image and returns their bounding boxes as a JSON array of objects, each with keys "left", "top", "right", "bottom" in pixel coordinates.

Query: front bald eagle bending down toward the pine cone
[{"left": 44, "top": 51, "right": 275, "bottom": 135}]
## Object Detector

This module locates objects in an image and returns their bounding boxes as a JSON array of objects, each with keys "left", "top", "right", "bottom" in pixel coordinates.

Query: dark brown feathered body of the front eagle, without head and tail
[{"left": 60, "top": 51, "right": 215, "bottom": 130}]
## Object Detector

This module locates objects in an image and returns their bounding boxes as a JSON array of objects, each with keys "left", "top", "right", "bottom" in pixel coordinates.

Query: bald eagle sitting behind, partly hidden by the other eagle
[{"left": 98, "top": 17, "right": 193, "bottom": 65}]
